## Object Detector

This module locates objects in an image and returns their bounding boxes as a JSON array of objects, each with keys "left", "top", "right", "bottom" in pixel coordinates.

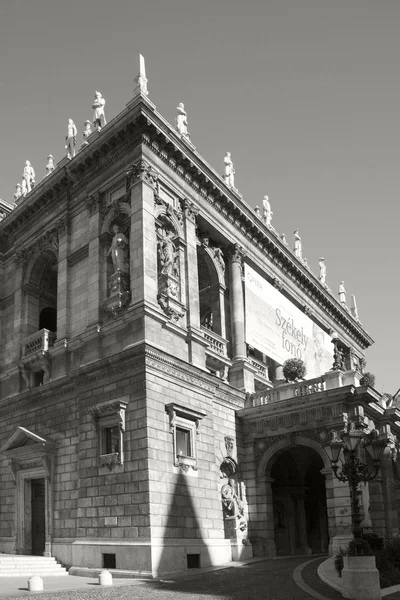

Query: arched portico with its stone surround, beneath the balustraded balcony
[{"left": 249, "top": 435, "right": 334, "bottom": 555}]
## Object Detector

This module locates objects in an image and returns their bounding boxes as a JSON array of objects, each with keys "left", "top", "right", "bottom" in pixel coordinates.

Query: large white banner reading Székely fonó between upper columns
[{"left": 245, "top": 264, "right": 333, "bottom": 379}]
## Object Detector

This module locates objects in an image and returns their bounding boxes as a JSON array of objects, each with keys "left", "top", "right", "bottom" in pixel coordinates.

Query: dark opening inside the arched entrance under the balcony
[{"left": 270, "top": 446, "right": 328, "bottom": 555}]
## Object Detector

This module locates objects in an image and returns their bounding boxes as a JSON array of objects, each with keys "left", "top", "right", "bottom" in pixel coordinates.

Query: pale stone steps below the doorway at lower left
[{"left": 0, "top": 554, "right": 68, "bottom": 577}]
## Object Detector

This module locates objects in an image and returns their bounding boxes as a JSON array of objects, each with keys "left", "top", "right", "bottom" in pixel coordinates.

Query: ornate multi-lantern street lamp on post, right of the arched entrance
[{"left": 325, "top": 406, "right": 388, "bottom": 546}]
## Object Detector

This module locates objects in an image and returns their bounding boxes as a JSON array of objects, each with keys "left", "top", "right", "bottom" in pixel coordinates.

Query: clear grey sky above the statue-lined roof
[{"left": 0, "top": 0, "right": 400, "bottom": 393}]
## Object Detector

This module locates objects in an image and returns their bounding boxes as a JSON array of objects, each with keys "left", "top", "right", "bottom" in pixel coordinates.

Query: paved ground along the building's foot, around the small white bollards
[{"left": 0, "top": 556, "right": 341, "bottom": 600}]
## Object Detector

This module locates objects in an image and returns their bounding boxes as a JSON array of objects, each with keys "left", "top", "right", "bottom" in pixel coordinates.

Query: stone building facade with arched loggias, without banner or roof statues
[{"left": 0, "top": 67, "right": 400, "bottom": 575}]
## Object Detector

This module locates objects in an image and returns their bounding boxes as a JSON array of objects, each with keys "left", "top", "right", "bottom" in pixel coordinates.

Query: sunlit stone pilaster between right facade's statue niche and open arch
[{"left": 183, "top": 200, "right": 208, "bottom": 369}]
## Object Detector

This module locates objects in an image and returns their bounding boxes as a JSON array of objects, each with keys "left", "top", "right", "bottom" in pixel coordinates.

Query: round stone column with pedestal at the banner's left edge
[{"left": 229, "top": 244, "right": 255, "bottom": 392}]
